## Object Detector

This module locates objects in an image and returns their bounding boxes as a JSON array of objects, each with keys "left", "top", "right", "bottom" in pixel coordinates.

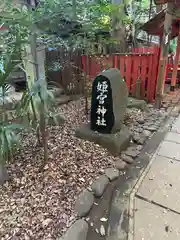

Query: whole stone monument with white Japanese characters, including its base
[{"left": 76, "top": 68, "right": 130, "bottom": 155}]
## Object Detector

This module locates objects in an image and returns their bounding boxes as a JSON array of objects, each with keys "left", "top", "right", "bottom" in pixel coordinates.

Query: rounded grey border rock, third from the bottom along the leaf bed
[{"left": 91, "top": 175, "right": 109, "bottom": 197}]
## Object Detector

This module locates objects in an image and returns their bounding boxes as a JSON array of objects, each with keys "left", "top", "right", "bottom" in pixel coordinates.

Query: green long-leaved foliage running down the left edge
[{"left": 0, "top": 49, "right": 22, "bottom": 164}]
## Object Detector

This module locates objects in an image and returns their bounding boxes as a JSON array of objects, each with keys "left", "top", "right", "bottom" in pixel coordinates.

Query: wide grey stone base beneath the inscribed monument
[{"left": 75, "top": 124, "right": 131, "bottom": 156}]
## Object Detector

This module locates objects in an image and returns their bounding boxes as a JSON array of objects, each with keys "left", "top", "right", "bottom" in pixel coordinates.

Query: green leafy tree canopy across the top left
[{"left": 0, "top": 0, "right": 129, "bottom": 51}]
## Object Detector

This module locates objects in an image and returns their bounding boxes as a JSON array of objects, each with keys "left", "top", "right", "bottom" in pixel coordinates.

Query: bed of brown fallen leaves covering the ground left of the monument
[{"left": 0, "top": 100, "right": 121, "bottom": 240}]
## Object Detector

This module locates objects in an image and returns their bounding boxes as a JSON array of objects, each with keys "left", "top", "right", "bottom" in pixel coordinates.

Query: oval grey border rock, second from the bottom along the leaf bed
[{"left": 75, "top": 189, "right": 94, "bottom": 217}]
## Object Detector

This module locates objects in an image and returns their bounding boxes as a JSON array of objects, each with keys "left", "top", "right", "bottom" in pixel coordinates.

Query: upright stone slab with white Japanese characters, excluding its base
[{"left": 91, "top": 69, "right": 127, "bottom": 134}]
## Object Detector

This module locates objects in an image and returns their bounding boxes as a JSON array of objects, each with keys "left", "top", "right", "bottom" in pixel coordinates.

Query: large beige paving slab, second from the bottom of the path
[{"left": 137, "top": 156, "right": 180, "bottom": 213}]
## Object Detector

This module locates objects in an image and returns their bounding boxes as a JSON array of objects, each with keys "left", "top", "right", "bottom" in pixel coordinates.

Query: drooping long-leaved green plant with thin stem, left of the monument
[{"left": 17, "top": 76, "right": 59, "bottom": 162}]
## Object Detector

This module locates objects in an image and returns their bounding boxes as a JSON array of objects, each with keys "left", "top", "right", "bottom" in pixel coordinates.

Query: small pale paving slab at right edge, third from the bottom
[{"left": 158, "top": 141, "right": 180, "bottom": 161}]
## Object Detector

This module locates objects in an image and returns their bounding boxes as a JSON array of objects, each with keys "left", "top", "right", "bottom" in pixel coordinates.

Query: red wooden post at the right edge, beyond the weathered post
[{"left": 171, "top": 28, "right": 180, "bottom": 92}]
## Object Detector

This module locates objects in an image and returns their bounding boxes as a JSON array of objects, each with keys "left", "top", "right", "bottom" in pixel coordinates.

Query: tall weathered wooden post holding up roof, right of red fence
[{"left": 155, "top": 3, "right": 173, "bottom": 108}]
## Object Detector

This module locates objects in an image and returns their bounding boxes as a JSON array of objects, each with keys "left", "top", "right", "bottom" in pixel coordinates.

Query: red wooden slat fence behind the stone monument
[{"left": 82, "top": 48, "right": 159, "bottom": 102}]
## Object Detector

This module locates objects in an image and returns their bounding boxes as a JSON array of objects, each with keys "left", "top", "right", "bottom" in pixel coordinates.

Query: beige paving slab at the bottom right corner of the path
[{"left": 134, "top": 198, "right": 180, "bottom": 240}]
